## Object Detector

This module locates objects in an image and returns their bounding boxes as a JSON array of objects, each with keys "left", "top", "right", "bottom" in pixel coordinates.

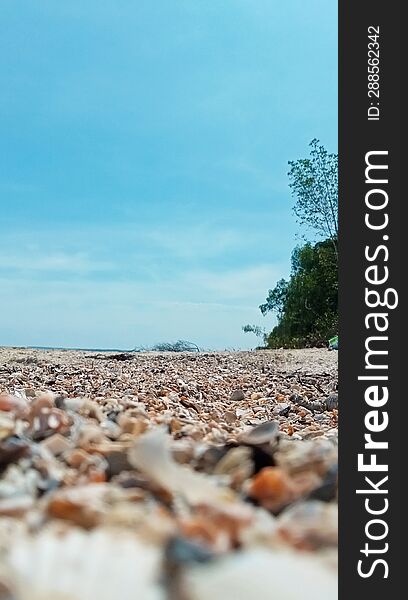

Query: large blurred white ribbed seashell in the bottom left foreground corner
[{"left": 5, "top": 525, "right": 163, "bottom": 600}]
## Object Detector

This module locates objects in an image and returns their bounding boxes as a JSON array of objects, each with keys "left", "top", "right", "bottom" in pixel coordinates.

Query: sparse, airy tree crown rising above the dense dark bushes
[{"left": 288, "top": 139, "right": 338, "bottom": 256}]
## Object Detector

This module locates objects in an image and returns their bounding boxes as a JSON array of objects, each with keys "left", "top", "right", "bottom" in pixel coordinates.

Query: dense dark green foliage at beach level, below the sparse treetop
[{"left": 259, "top": 239, "right": 338, "bottom": 348}]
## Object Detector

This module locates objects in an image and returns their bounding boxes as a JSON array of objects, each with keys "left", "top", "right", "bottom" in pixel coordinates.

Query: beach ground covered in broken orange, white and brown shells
[{"left": 0, "top": 349, "right": 338, "bottom": 600}]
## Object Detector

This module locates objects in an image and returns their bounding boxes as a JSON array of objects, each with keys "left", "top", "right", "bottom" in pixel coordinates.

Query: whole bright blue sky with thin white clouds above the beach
[{"left": 0, "top": 0, "right": 337, "bottom": 349}]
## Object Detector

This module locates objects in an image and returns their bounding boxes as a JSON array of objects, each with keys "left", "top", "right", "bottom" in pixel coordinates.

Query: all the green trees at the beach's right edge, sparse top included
[{"left": 243, "top": 139, "right": 338, "bottom": 348}]
